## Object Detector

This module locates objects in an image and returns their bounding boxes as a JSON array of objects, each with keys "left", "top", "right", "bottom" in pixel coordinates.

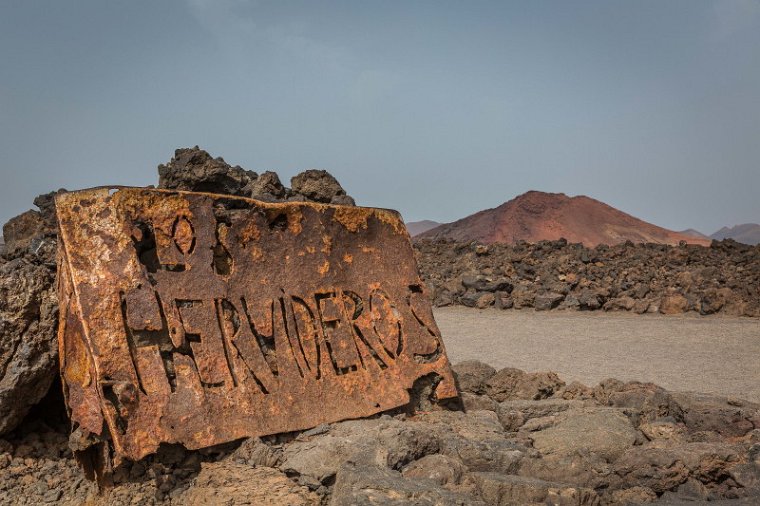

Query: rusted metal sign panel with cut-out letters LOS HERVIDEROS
[{"left": 56, "top": 188, "right": 456, "bottom": 459}]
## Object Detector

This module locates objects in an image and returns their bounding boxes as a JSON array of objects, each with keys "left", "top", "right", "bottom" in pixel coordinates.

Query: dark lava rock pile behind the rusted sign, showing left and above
[{"left": 0, "top": 146, "right": 353, "bottom": 435}]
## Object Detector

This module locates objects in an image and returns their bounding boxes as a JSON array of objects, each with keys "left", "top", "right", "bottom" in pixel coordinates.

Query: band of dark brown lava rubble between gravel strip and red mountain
[{"left": 414, "top": 240, "right": 760, "bottom": 317}]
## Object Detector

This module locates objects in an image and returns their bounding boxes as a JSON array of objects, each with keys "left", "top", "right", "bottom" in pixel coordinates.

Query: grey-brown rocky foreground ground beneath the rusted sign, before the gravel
[{"left": 0, "top": 361, "right": 760, "bottom": 506}]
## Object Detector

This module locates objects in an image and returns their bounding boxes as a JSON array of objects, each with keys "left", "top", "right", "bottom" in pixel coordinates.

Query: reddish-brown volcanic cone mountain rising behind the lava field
[{"left": 417, "top": 191, "right": 710, "bottom": 246}]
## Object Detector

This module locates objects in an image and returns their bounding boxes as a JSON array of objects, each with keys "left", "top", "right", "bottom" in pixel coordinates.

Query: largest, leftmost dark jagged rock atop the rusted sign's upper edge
[{"left": 158, "top": 146, "right": 257, "bottom": 197}]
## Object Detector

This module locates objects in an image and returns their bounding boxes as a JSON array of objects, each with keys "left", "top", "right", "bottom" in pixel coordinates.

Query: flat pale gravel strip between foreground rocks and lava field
[{"left": 435, "top": 307, "right": 760, "bottom": 402}]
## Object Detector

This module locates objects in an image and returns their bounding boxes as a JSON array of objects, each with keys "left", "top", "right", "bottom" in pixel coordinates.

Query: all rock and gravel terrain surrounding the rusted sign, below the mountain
[{"left": 0, "top": 147, "right": 760, "bottom": 506}]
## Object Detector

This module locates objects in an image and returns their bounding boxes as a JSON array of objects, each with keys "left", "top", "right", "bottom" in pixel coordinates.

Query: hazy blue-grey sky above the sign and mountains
[{"left": 0, "top": 0, "right": 760, "bottom": 233}]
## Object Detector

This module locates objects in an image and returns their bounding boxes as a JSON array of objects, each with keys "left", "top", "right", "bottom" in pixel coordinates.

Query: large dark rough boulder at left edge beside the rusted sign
[{"left": 0, "top": 258, "right": 58, "bottom": 434}]
